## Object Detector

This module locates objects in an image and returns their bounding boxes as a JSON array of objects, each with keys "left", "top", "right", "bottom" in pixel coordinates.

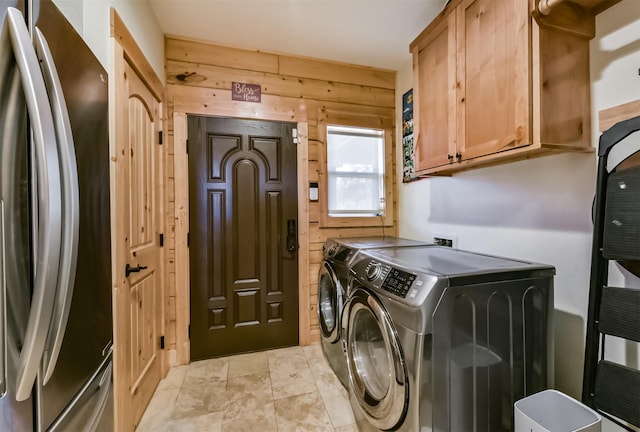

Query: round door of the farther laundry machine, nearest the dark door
[{"left": 318, "top": 261, "right": 343, "bottom": 343}]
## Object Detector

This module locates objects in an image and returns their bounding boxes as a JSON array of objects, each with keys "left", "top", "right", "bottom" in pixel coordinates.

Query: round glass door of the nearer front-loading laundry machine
[{"left": 345, "top": 288, "right": 409, "bottom": 430}]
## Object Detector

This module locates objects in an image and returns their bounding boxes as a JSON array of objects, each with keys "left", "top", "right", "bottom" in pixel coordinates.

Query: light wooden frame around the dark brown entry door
[{"left": 173, "top": 106, "right": 311, "bottom": 364}]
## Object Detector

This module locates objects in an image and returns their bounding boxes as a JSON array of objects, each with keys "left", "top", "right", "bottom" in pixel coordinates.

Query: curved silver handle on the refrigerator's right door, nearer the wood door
[{"left": 34, "top": 27, "right": 80, "bottom": 385}]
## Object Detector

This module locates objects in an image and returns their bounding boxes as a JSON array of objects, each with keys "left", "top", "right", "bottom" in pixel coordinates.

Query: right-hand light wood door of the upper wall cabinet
[{"left": 456, "top": 0, "right": 531, "bottom": 159}]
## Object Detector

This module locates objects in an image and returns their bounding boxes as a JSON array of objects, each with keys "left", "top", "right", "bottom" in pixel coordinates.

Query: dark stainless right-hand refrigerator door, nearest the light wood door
[{"left": 32, "top": 0, "right": 113, "bottom": 431}]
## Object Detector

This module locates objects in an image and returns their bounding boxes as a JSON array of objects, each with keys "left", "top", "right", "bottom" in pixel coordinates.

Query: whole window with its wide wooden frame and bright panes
[{"left": 318, "top": 108, "right": 394, "bottom": 227}]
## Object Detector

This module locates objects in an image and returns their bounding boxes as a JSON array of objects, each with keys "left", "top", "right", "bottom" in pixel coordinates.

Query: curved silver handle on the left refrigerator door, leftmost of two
[{"left": 0, "top": 8, "right": 62, "bottom": 401}]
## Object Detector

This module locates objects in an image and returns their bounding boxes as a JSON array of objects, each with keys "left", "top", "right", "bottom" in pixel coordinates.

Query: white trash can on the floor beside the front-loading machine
[{"left": 513, "top": 390, "right": 602, "bottom": 432}]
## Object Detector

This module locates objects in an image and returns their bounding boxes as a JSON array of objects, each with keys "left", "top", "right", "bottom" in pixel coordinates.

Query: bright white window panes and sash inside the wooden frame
[{"left": 327, "top": 126, "right": 385, "bottom": 217}]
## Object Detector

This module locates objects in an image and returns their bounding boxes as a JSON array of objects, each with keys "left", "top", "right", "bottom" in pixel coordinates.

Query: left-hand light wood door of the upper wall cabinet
[{"left": 411, "top": 13, "right": 456, "bottom": 173}]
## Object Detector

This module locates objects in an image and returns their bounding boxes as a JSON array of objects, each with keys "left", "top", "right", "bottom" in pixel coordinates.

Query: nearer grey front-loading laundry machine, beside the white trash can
[{"left": 344, "top": 246, "right": 555, "bottom": 432}]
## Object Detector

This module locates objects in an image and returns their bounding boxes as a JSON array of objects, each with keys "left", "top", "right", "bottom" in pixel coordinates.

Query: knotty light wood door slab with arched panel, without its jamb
[{"left": 126, "top": 60, "right": 162, "bottom": 423}]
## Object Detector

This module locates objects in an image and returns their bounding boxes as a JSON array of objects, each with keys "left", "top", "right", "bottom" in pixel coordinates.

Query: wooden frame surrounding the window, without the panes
[{"left": 318, "top": 109, "right": 395, "bottom": 227}]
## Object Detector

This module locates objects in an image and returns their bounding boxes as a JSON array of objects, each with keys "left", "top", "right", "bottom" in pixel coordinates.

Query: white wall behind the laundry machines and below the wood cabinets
[{"left": 396, "top": 0, "right": 640, "bottom": 398}]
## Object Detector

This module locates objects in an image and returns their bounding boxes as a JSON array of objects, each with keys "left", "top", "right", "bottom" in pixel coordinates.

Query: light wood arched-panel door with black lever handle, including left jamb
[{"left": 114, "top": 62, "right": 163, "bottom": 430}]
